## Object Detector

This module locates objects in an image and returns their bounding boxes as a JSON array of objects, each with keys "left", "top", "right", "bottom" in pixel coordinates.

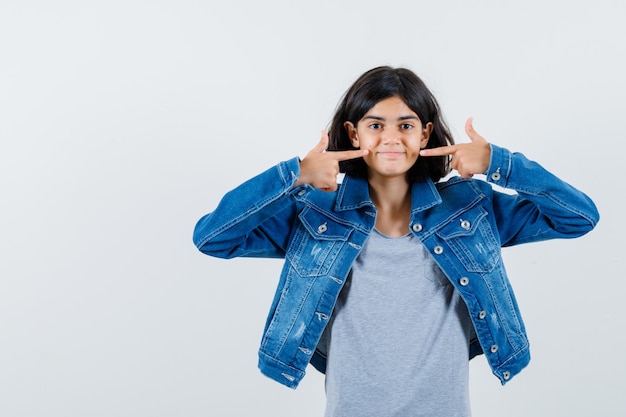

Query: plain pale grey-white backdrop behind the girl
[{"left": 0, "top": 0, "right": 626, "bottom": 417}]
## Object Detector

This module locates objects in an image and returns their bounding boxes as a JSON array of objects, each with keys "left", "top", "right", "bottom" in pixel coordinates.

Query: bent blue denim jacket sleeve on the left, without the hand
[{"left": 193, "top": 158, "right": 300, "bottom": 258}]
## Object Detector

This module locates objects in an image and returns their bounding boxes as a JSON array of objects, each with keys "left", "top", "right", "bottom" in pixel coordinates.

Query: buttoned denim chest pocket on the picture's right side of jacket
[{"left": 437, "top": 206, "right": 500, "bottom": 272}]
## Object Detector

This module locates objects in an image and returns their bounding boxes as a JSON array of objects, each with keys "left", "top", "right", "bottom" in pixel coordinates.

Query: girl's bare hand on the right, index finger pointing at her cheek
[{"left": 420, "top": 117, "right": 491, "bottom": 178}]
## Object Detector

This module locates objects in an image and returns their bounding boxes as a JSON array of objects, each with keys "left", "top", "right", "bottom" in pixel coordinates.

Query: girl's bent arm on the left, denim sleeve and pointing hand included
[{"left": 193, "top": 131, "right": 367, "bottom": 258}]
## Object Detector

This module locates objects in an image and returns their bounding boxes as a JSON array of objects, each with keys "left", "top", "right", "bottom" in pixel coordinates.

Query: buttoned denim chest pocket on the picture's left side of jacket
[{"left": 286, "top": 207, "right": 352, "bottom": 276}]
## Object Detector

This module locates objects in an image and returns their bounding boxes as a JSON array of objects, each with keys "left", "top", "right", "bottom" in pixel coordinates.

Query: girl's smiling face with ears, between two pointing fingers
[{"left": 344, "top": 97, "right": 433, "bottom": 179}]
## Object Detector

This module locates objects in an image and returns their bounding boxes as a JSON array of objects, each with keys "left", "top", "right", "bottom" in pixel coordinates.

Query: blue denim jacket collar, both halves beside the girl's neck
[{"left": 335, "top": 175, "right": 441, "bottom": 215}]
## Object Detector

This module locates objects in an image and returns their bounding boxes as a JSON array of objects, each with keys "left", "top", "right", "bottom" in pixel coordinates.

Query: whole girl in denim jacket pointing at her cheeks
[{"left": 194, "top": 67, "right": 599, "bottom": 417}]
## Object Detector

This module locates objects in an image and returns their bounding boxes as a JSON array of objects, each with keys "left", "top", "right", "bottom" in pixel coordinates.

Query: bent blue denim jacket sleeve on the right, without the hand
[{"left": 486, "top": 144, "right": 599, "bottom": 246}]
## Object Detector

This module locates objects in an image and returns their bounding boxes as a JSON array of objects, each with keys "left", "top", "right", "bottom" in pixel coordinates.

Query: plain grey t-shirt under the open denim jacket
[{"left": 325, "top": 230, "right": 472, "bottom": 417}]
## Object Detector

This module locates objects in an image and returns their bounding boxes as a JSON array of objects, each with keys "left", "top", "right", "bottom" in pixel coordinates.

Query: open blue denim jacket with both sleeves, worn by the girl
[{"left": 193, "top": 145, "right": 599, "bottom": 388}]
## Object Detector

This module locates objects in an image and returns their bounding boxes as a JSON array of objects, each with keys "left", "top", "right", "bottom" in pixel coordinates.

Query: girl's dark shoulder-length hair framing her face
[{"left": 328, "top": 66, "right": 454, "bottom": 181}]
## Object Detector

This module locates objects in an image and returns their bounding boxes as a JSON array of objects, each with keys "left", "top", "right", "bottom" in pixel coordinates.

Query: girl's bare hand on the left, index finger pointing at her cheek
[{"left": 294, "top": 130, "right": 369, "bottom": 191}]
